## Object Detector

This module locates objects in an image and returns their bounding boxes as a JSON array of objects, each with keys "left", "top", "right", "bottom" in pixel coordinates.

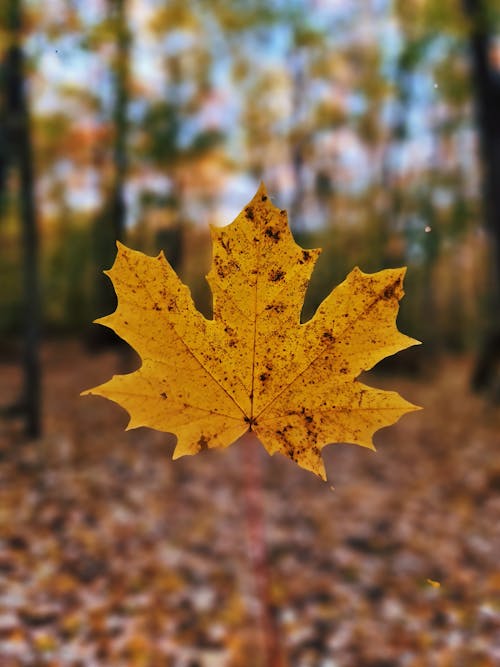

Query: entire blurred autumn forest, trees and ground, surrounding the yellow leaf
[{"left": 0, "top": 0, "right": 500, "bottom": 667}]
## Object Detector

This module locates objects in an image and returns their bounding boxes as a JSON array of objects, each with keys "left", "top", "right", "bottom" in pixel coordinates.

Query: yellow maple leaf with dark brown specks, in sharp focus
[{"left": 83, "top": 185, "right": 418, "bottom": 479}]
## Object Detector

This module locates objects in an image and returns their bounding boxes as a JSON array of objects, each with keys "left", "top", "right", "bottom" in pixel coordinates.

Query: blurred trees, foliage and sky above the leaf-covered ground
[{"left": 0, "top": 0, "right": 500, "bottom": 374}]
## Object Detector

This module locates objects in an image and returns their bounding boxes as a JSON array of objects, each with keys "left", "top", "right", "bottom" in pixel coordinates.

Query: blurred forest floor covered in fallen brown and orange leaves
[{"left": 0, "top": 342, "right": 500, "bottom": 667}]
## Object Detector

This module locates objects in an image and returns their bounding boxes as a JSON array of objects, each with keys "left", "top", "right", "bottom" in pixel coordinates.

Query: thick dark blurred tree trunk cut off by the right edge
[{"left": 464, "top": 0, "right": 500, "bottom": 389}]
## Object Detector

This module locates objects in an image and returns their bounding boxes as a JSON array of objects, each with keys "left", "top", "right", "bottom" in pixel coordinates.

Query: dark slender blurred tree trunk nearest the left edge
[{"left": 3, "top": 0, "right": 41, "bottom": 437}]
